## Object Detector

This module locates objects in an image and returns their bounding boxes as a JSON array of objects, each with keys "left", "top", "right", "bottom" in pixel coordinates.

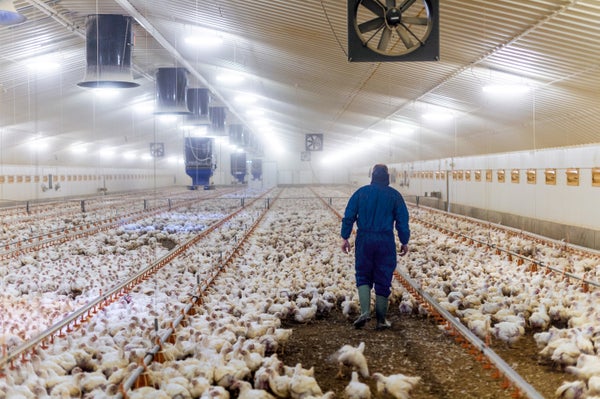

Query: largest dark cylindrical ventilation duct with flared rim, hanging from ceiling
[{"left": 77, "top": 14, "right": 139, "bottom": 88}]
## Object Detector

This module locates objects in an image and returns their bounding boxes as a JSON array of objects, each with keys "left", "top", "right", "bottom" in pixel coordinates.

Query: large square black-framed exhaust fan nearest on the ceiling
[{"left": 348, "top": 0, "right": 440, "bottom": 62}]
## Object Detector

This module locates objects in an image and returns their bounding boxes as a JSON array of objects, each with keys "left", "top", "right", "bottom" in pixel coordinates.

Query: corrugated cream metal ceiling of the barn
[{"left": 0, "top": 0, "right": 600, "bottom": 167}]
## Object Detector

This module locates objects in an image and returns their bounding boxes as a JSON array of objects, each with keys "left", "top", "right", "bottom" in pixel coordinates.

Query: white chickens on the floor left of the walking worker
[{"left": 0, "top": 189, "right": 418, "bottom": 398}]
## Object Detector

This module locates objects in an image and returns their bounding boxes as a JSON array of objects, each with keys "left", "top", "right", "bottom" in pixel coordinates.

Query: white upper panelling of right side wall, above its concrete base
[{"left": 366, "top": 145, "right": 600, "bottom": 230}]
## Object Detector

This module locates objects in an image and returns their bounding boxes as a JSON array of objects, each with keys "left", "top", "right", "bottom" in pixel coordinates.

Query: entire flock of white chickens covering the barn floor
[{"left": 0, "top": 187, "right": 600, "bottom": 399}]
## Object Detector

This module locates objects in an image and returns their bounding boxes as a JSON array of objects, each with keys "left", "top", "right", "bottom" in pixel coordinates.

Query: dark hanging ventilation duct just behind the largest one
[{"left": 154, "top": 68, "right": 190, "bottom": 115}]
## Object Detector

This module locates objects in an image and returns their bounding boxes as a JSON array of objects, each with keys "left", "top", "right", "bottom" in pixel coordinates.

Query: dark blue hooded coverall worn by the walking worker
[{"left": 341, "top": 172, "right": 410, "bottom": 298}]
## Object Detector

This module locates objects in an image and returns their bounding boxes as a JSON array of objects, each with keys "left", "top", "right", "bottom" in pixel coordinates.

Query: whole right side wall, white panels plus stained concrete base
[{"left": 351, "top": 145, "right": 600, "bottom": 248}]
